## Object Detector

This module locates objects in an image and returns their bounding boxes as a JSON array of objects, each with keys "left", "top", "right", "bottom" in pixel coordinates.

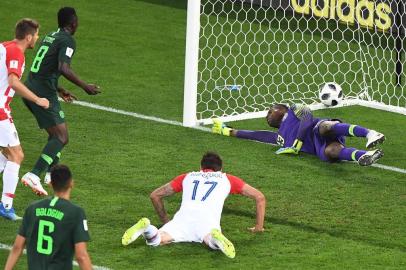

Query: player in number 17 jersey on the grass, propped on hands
[{"left": 122, "top": 152, "right": 266, "bottom": 258}]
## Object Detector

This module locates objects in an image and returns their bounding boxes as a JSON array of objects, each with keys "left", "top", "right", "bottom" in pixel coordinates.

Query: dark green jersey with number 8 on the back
[{"left": 26, "top": 29, "right": 76, "bottom": 97}]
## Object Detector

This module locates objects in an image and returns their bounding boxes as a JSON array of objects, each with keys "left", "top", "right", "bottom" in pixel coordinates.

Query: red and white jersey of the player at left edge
[{"left": 0, "top": 41, "right": 25, "bottom": 121}]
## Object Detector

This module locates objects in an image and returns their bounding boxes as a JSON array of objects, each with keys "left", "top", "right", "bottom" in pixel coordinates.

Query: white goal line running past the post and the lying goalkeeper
[{"left": 73, "top": 101, "right": 406, "bottom": 174}]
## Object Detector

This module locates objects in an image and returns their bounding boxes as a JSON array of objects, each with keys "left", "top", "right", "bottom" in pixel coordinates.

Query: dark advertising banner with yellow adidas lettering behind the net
[{"left": 243, "top": 0, "right": 406, "bottom": 32}]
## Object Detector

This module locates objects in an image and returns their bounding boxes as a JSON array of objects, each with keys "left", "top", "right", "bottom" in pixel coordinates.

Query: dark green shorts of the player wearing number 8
[{"left": 23, "top": 98, "right": 65, "bottom": 129}]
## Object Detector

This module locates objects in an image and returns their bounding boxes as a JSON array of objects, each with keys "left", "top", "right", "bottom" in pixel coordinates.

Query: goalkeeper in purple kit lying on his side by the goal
[{"left": 212, "top": 104, "right": 385, "bottom": 166}]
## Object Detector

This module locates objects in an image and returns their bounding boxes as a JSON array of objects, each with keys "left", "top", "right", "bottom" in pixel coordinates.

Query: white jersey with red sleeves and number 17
[{"left": 171, "top": 170, "right": 245, "bottom": 226}]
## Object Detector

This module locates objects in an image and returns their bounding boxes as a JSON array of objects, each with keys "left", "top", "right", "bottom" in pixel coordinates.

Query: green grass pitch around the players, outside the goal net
[{"left": 0, "top": 0, "right": 406, "bottom": 269}]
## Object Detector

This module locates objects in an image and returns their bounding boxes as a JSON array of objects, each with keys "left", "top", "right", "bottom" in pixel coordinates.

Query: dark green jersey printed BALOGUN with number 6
[{"left": 18, "top": 197, "right": 90, "bottom": 270}]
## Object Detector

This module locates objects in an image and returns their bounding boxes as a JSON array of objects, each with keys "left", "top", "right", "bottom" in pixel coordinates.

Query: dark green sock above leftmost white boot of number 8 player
[{"left": 31, "top": 137, "right": 64, "bottom": 176}]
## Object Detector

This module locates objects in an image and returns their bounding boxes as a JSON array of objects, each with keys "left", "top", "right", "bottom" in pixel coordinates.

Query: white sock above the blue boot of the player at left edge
[{"left": 1, "top": 161, "right": 20, "bottom": 209}]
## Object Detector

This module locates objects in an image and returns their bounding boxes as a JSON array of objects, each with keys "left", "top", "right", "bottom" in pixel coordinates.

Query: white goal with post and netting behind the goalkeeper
[{"left": 183, "top": 0, "right": 406, "bottom": 126}]
